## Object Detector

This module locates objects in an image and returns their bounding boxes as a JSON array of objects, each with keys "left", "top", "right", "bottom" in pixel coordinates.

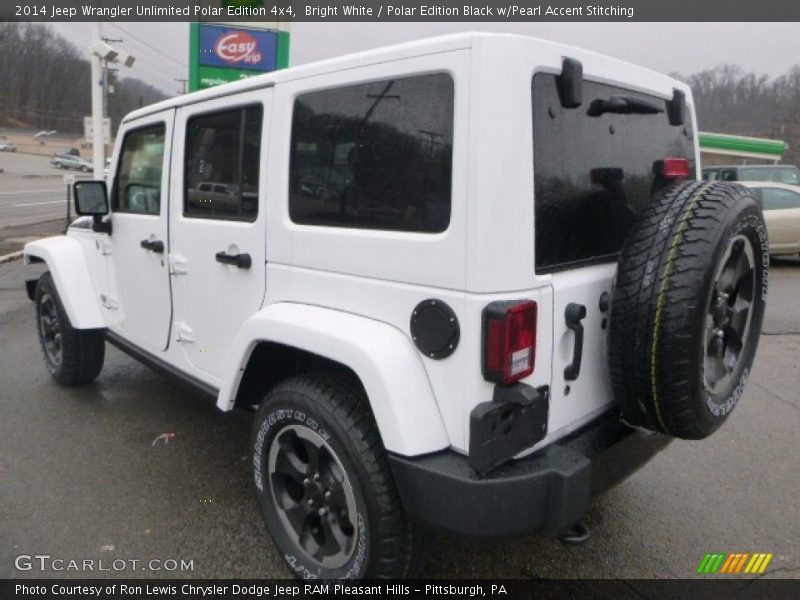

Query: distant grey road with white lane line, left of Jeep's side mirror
[{"left": 0, "top": 152, "right": 79, "bottom": 228}]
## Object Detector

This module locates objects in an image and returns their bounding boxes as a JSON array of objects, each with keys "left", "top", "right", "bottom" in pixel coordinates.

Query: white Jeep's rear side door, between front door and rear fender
[{"left": 170, "top": 89, "right": 272, "bottom": 385}]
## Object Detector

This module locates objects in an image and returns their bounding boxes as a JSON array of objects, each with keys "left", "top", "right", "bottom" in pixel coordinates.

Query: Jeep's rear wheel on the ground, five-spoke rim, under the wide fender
[{"left": 253, "top": 373, "right": 422, "bottom": 579}]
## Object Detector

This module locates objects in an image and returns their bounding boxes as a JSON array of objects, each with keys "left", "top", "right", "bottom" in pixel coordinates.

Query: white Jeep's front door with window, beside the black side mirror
[{"left": 101, "top": 110, "right": 174, "bottom": 353}]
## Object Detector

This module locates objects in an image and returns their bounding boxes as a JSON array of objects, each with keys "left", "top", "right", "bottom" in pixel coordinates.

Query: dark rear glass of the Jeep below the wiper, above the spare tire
[{"left": 532, "top": 73, "right": 695, "bottom": 273}]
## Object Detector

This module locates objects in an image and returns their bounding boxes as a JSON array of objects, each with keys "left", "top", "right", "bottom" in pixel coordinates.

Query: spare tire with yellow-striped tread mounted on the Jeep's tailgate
[{"left": 609, "top": 181, "right": 769, "bottom": 439}]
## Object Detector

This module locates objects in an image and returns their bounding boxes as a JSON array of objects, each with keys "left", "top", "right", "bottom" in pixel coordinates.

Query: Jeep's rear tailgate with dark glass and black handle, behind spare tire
[{"left": 533, "top": 73, "right": 695, "bottom": 431}]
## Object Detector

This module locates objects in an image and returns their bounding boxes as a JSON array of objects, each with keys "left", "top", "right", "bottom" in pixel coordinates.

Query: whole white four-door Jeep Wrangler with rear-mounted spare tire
[{"left": 25, "top": 34, "right": 768, "bottom": 578}]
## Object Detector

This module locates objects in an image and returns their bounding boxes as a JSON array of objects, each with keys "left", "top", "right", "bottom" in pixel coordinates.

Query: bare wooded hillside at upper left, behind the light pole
[{"left": 0, "top": 23, "right": 167, "bottom": 133}]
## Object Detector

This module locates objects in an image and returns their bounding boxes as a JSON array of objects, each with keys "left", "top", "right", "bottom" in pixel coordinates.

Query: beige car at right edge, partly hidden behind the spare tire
[{"left": 742, "top": 181, "right": 800, "bottom": 255}]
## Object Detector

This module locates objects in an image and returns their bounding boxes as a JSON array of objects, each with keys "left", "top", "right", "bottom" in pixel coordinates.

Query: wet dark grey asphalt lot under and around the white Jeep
[{"left": 0, "top": 261, "right": 800, "bottom": 578}]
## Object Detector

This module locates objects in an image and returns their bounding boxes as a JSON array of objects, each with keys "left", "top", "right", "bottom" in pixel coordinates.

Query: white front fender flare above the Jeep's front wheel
[{"left": 23, "top": 235, "right": 105, "bottom": 329}]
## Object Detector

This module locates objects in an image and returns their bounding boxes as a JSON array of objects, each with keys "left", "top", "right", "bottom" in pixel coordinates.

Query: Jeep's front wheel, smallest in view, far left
[{"left": 34, "top": 272, "right": 106, "bottom": 387}]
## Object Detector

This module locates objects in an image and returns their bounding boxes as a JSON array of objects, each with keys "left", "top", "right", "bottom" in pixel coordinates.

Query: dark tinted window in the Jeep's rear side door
[{"left": 183, "top": 106, "right": 263, "bottom": 222}]
